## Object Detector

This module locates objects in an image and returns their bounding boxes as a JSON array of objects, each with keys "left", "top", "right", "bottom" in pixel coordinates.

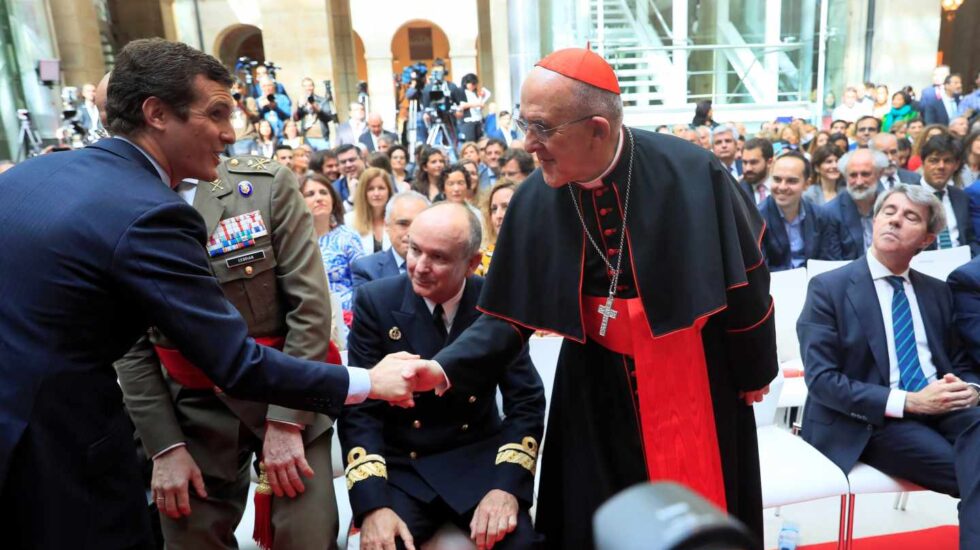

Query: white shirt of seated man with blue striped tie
[{"left": 865, "top": 250, "right": 936, "bottom": 418}]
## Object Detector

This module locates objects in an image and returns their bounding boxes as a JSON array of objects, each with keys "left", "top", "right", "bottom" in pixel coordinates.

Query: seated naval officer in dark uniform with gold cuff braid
[{"left": 340, "top": 203, "right": 545, "bottom": 549}]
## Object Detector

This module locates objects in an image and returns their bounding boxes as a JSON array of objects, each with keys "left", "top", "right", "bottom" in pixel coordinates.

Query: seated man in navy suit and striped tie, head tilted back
[{"left": 797, "top": 184, "right": 980, "bottom": 548}]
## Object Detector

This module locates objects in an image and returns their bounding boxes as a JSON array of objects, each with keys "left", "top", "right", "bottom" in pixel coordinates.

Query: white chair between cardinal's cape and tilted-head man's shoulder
[{"left": 769, "top": 267, "right": 807, "bottom": 408}]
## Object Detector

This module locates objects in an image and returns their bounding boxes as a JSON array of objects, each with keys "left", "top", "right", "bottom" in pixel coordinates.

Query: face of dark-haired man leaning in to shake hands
[{"left": 156, "top": 75, "right": 235, "bottom": 182}]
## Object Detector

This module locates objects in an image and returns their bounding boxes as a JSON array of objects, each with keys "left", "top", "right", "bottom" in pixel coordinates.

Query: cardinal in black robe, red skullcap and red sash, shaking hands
[{"left": 426, "top": 49, "right": 777, "bottom": 549}]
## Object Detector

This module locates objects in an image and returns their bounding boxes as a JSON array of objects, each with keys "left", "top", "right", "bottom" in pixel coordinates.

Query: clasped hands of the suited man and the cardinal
[{"left": 368, "top": 351, "right": 449, "bottom": 407}]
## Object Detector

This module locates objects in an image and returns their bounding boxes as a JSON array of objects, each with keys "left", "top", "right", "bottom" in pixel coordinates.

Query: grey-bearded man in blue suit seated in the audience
[{"left": 822, "top": 149, "right": 888, "bottom": 260}]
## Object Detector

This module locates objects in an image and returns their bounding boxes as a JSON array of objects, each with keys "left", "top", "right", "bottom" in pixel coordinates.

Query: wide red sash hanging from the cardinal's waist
[{"left": 582, "top": 296, "right": 727, "bottom": 510}]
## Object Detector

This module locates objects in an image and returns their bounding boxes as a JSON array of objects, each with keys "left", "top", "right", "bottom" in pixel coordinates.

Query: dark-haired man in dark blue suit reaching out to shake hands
[{"left": 0, "top": 39, "right": 431, "bottom": 549}]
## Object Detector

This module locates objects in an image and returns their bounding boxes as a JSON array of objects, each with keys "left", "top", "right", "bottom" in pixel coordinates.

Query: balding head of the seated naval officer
[{"left": 406, "top": 204, "right": 480, "bottom": 304}]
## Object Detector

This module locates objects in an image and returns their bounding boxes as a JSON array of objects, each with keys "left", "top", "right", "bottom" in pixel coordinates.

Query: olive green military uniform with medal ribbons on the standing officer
[{"left": 116, "top": 156, "right": 337, "bottom": 550}]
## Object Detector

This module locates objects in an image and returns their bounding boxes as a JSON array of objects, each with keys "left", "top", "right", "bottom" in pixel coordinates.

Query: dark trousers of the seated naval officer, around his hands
[{"left": 388, "top": 485, "right": 537, "bottom": 550}]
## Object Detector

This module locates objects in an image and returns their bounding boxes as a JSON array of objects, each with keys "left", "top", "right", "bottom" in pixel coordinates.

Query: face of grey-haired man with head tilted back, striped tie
[{"left": 871, "top": 193, "right": 936, "bottom": 260}]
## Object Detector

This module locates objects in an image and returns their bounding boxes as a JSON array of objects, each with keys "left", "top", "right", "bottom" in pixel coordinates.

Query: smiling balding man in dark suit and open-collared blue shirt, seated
[{"left": 759, "top": 151, "right": 840, "bottom": 271}]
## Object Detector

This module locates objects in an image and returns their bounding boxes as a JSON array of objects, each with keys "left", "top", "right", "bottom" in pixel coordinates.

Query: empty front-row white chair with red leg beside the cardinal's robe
[{"left": 754, "top": 372, "right": 848, "bottom": 548}]
